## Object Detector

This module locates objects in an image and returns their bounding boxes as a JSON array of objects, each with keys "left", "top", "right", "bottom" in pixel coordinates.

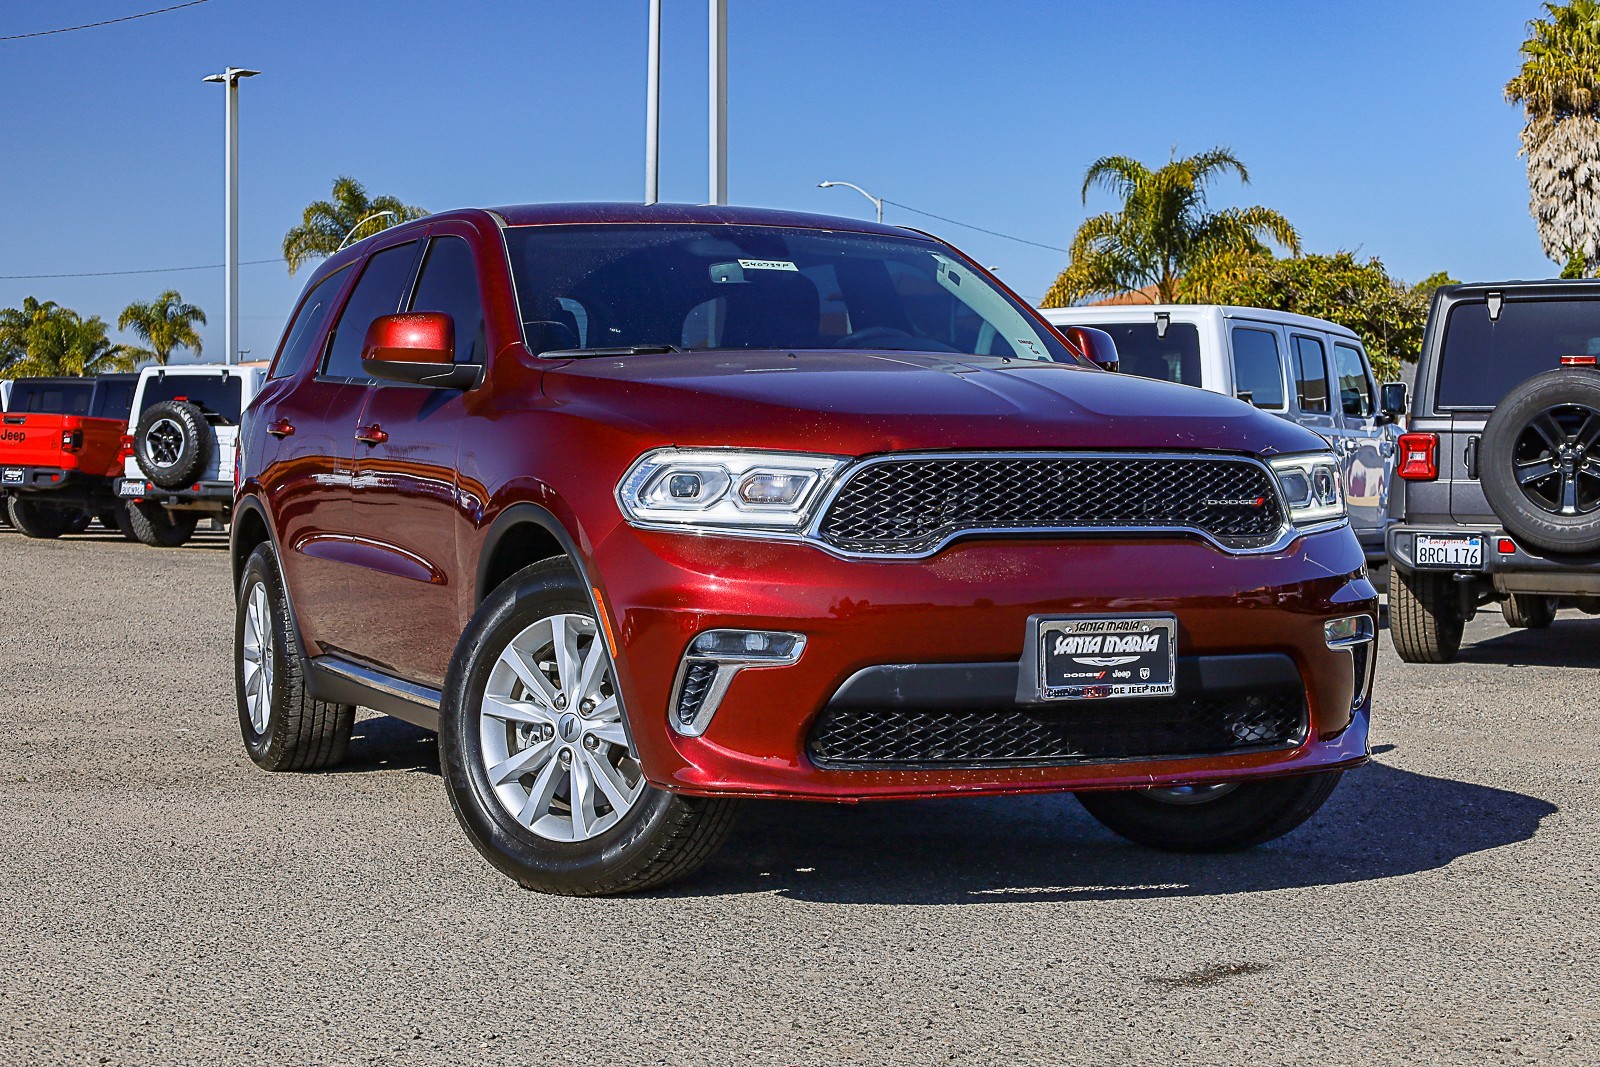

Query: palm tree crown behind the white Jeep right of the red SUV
[{"left": 1043, "top": 149, "right": 1299, "bottom": 307}]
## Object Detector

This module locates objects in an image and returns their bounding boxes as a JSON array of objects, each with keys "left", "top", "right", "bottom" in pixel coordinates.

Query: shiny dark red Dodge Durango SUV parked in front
[{"left": 232, "top": 205, "right": 1378, "bottom": 894}]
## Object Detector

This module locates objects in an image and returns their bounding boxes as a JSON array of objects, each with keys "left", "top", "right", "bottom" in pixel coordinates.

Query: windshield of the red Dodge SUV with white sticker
[{"left": 506, "top": 224, "right": 1077, "bottom": 363}]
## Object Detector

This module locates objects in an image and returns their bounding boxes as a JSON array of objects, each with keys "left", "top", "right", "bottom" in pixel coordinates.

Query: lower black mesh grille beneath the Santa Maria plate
[{"left": 806, "top": 688, "right": 1306, "bottom": 769}]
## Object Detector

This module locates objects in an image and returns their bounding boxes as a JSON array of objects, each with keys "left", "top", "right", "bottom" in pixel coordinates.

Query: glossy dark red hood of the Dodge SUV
[{"left": 544, "top": 350, "right": 1328, "bottom": 456}]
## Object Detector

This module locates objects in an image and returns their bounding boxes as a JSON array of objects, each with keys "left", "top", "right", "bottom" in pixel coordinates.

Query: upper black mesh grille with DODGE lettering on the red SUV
[{"left": 819, "top": 454, "right": 1283, "bottom": 553}]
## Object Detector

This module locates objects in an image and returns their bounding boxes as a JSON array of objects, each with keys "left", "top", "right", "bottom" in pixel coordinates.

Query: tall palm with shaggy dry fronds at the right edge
[{"left": 1506, "top": 0, "right": 1600, "bottom": 275}]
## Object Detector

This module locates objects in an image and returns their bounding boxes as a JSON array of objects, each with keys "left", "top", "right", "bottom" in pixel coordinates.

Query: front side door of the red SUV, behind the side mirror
[{"left": 340, "top": 224, "right": 488, "bottom": 686}]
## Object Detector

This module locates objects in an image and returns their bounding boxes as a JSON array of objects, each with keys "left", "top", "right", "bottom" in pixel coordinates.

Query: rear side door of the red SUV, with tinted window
[{"left": 275, "top": 240, "right": 419, "bottom": 653}]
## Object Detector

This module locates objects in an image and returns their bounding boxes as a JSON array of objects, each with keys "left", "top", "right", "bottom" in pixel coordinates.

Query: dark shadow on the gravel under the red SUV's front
[{"left": 681, "top": 763, "right": 1557, "bottom": 904}]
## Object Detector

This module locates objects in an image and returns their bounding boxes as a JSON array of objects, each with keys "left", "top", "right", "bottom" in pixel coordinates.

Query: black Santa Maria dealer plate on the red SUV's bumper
[{"left": 1037, "top": 614, "right": 1178, "bottom": 701}]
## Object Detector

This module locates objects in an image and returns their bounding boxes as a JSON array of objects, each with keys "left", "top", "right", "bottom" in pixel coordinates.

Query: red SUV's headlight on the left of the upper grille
[{"left": 616, "top": 448, "right": 845, "bottom": 533}]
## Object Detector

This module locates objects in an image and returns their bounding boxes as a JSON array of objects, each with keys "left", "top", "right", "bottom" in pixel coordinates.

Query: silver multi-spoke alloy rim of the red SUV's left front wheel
[{"left": 478, "top": 614, "right": 645, "bottom": 841}]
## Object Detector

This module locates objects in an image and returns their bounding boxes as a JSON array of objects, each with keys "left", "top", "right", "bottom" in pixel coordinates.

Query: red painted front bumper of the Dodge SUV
[{"left": 590, "top": 526, "right": 1378, "bottom": 801}]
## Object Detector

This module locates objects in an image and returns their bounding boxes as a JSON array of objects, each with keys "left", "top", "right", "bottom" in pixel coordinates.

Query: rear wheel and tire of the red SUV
[{"left": 234, "top": 544, "right": 355, "bottom": 771}]
